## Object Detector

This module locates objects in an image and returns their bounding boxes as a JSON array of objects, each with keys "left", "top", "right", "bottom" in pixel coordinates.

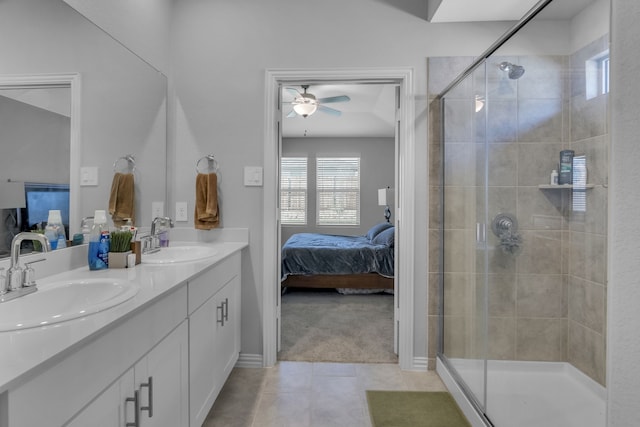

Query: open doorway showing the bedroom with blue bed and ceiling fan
[{"left": 278, "top": 82, "right": 398, "bottom": 363}]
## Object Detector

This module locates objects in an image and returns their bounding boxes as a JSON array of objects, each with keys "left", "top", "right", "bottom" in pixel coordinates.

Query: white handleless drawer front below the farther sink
[{"left": 189, "top": 252, "right": 240, "bottom": 314}]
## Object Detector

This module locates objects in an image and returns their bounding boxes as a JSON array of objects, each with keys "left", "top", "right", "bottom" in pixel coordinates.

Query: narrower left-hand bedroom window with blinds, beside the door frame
[{"left": 280, "top": 157, "right": 307, "bottom": 225}]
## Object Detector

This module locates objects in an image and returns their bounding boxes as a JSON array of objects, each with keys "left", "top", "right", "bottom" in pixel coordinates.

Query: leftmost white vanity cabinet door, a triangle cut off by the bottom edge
[{"left": 66, "top": 370, "right": 135, "bottom": 427}]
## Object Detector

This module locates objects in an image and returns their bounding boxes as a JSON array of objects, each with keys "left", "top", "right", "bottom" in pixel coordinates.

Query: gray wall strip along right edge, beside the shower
[{"left": 607, "top": 0, "right": 640, "bottom": 427}]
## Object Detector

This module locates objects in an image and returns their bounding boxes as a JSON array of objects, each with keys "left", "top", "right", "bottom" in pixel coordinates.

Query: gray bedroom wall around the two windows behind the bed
[{"left": 282, "top": 138, "right": 395, "bottom": 243}]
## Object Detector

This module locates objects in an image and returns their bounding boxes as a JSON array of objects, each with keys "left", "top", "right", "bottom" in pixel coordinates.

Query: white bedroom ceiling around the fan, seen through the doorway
[{"left": 282, "top": 83, "right": 395, "bottom": 138}]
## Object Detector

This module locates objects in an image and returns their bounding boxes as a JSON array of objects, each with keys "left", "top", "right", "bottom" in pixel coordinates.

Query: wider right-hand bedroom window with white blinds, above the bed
[{"left": 316, "top": 157, "right": 360, "bottom": 225}]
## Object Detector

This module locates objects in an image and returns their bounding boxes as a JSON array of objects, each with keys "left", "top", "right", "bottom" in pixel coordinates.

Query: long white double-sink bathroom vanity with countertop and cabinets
[{"left": 0, "top": 236, "right": 247, "bottom": 427}]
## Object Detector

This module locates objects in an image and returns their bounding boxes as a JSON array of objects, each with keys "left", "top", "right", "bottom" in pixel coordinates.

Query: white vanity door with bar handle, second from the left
[{"left": 134, "top": 321, "right": 189, "bottom": 427}]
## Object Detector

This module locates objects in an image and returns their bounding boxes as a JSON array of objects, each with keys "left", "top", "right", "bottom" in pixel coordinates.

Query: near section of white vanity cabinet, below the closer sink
[{"left": 8, "top": 284, "right": 189, "bottom": 427}]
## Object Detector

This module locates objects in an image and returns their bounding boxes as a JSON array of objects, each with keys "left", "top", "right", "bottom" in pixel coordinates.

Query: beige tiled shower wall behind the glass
[{"left": 428, "top": 38, "right": 608, "bottom": 384}]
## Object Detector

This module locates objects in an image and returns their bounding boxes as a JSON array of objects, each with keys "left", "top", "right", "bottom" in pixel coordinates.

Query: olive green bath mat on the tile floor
[{"left": 367, "top": 390, "right": 471, "bottom": 427}]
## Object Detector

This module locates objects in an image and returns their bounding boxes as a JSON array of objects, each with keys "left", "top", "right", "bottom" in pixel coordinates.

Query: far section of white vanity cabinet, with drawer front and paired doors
[{"left": 188, "top": 253, "right": 240, "bottom": 427}]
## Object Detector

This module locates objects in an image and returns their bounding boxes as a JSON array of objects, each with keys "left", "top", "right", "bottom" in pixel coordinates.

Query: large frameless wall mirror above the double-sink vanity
[{"left": 0, "top": 0, "right": 167, "bottom": 257}]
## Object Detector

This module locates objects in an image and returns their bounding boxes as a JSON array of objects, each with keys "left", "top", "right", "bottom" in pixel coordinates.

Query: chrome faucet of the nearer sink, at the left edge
[{"left": 0, "top": 232, "right": 51, "bottom": 302}]
